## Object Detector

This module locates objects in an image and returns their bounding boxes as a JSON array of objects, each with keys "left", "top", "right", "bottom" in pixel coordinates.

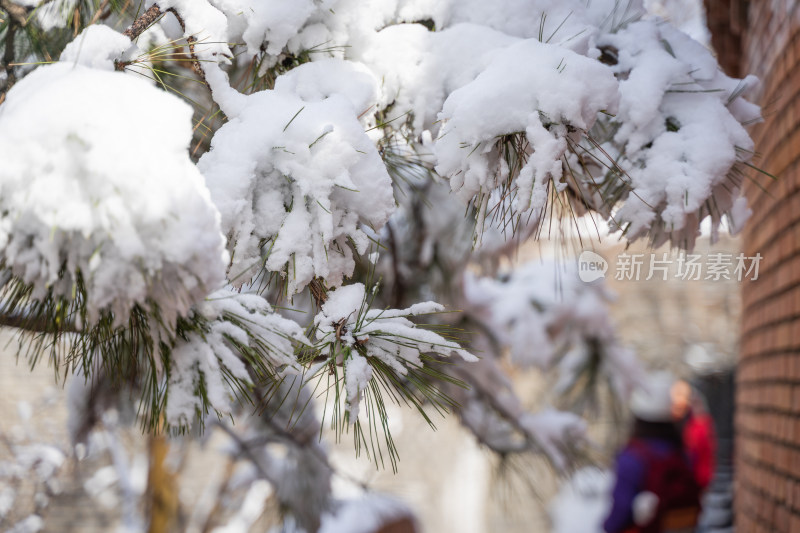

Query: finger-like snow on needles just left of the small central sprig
[{"left": 166, "top": 289, "right": 309, "bottom": 426}]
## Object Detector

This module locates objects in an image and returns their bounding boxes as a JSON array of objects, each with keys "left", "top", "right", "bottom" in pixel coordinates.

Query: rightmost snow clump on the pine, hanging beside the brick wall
[{"left": 597, "top": 21, "right": 760, "bottom": 248}]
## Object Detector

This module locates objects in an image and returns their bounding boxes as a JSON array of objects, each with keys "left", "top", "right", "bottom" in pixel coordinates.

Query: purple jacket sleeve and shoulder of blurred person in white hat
[{"left": 603, "top": 439, "right": 673, "bottom": 533}]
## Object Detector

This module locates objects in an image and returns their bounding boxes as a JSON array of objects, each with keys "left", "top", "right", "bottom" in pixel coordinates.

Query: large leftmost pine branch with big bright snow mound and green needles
[{"left": 0, "top": 26, "right": 316, "bottom": 428}]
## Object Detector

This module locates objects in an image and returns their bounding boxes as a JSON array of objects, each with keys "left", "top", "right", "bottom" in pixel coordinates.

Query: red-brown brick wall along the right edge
[{"left": 706, "top": 0, "right": 800, "bottom": 532}]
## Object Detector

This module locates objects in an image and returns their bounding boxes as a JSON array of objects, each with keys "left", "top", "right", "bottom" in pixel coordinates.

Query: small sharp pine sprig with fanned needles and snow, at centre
[{"left": 314, "top": 283, "right": 477, "bottom": 466}]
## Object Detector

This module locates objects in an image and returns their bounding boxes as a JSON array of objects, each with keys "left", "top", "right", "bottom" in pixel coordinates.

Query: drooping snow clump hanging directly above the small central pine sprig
[{"left": 198, "top": 65, "right": 395, "bottom": 294}]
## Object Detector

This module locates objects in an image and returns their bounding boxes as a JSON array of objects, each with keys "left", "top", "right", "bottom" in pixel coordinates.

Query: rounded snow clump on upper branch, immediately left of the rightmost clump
[{"left": 436, "top": 39, "right": 618, "bottom": 236}]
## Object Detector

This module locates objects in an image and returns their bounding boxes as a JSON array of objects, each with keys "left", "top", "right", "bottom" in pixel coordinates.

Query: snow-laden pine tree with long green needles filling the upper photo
[{"left": 0, "top": 0, "right": 759, "bottom": 532}]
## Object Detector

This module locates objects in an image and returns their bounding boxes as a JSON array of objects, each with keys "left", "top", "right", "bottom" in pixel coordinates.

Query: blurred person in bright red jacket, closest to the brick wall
[{"left": 672, "top": 381, "right": 717, "bottom": 490}]
